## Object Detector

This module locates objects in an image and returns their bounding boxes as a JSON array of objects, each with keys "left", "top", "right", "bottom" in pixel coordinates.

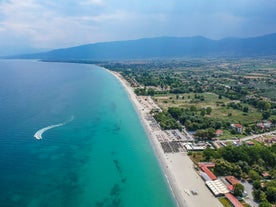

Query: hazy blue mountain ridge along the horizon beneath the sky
[{"left": 7, "top": 33, "right": 276, "bottom": 61}]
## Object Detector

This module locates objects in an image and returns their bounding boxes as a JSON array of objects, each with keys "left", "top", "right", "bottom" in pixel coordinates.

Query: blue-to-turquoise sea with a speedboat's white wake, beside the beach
[{"left": 0, "top": 60, "right": 176, "bottom": 207}]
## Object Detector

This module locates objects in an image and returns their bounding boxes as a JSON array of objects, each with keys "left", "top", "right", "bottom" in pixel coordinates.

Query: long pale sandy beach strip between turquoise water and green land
[{"left": 104, "top": 68, "right": 222, "bottom": 207}]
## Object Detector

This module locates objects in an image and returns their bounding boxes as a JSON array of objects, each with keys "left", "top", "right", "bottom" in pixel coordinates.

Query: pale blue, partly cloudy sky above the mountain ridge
[{"left": 0, "top": 0, "right": 276, "bottom": 56}]
